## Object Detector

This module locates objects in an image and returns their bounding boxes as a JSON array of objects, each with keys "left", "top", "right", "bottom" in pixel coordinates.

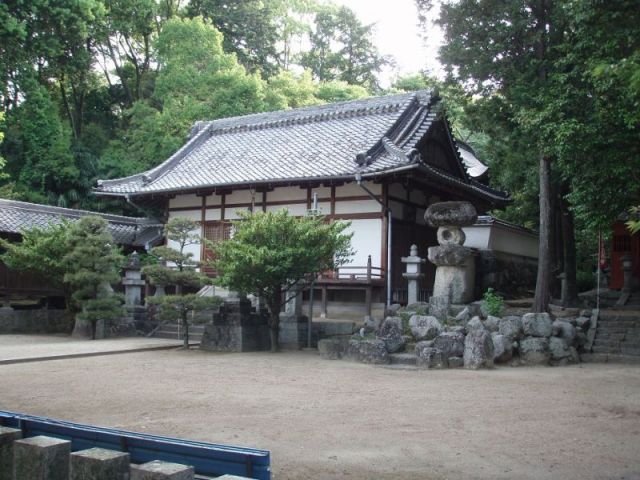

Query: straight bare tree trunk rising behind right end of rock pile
[{"left": 533, "top": 155, "right": 551, "bottom": 312}]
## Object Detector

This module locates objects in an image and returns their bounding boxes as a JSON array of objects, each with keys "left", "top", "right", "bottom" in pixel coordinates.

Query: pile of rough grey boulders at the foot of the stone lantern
[{"left": 318, "top": 303, "right": 591, "bottom": 369}]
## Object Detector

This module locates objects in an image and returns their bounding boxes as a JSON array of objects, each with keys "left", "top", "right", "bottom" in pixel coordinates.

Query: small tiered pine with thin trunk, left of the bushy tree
[{"left": 143, "top": 218, "right": 221, "bottom": 349}]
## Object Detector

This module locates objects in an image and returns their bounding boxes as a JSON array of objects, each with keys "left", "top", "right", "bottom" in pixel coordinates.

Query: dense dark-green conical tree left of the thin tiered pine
[{"left": 62, "top": 216, "right": 125, "bottom": 339}]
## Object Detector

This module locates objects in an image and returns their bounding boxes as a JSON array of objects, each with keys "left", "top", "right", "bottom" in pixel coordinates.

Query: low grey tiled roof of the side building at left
[{"left": 0, "top": 199, "right": 162, "bottom": 246}]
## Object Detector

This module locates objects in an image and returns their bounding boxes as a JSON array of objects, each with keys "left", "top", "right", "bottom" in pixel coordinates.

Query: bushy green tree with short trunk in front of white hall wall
[{"left": 212, "top": 209, "right": 351, "bottom": 352}]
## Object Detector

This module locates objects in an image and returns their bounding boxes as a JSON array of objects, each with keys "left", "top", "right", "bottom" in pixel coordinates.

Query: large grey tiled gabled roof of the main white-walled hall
[{"left": 95, "top": 91, "right": 508, "bottom": 204}]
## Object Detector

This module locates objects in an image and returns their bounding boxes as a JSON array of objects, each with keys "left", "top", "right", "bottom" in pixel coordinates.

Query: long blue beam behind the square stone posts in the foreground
[{"left": 0, "top": 410, "right": 271, "bottom": 480}]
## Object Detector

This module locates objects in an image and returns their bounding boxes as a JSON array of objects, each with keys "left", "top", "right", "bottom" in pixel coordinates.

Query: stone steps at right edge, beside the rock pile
[{"left": 593, "top": 309, "right": 640, "bottom": 358}]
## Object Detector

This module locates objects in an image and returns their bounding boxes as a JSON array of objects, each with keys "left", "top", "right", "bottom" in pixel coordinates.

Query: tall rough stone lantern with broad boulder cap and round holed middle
[{"left": 424, "top": 202, "right": 478, "bottom": 304}]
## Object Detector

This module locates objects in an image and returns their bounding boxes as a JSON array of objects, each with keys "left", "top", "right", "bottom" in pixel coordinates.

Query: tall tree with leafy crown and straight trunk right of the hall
[{"left": 424, "top": 0, "right": 566, "bottom": 311}]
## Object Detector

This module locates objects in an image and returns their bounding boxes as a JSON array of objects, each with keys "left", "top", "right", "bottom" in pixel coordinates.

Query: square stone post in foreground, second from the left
[{"left": 13, "top": 435, "right": 71, "bottom": 480}]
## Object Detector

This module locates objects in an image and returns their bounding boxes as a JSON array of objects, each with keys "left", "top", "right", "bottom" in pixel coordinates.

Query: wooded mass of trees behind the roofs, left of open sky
[{"left": 0, "top": 0, "right": 386, "bottom": 210}]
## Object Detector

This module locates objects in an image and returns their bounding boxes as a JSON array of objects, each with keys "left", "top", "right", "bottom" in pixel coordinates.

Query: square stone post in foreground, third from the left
[{"left": 69, "top": 448, "right": 130, "bottom": 480}]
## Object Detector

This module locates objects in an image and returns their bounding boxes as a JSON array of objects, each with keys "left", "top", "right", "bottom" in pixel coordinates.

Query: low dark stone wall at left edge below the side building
[{"left": 0, "top": 308, "right": 73, "bottom": 334}]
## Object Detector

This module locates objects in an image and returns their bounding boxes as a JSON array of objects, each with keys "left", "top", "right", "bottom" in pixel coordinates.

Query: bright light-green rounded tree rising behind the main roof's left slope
[{"left": 101, "top": 17, "right": 265, "bottom": 175}]
